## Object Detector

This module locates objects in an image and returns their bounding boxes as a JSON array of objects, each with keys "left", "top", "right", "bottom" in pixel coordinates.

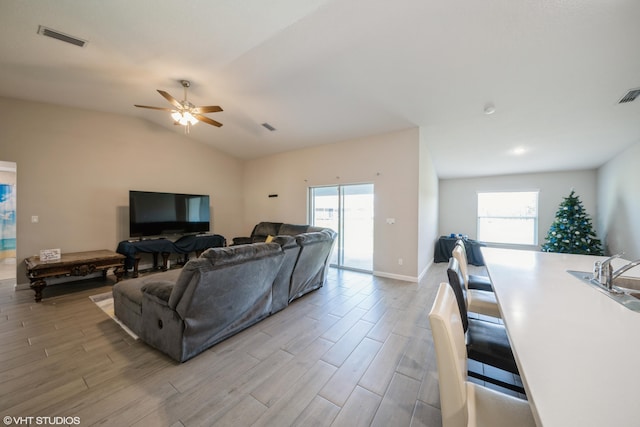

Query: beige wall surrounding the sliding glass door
[{"left": 244, "top": 128, "right": 437, "bottom": 280}]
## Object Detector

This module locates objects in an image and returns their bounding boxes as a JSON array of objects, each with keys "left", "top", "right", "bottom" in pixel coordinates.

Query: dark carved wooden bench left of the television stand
[{"left": 25, "top": 249, "right": 125, "bottom": 302}]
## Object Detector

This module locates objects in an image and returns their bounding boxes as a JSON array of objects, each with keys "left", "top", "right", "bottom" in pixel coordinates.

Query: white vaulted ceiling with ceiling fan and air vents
[{"left": 0, "top": 0, "right": 640, "bottom": 178}]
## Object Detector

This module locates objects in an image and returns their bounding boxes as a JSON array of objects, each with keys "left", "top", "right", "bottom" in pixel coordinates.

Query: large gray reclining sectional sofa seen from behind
[{"left": 113, "top": 229, "right": 336, "bottom": 362}]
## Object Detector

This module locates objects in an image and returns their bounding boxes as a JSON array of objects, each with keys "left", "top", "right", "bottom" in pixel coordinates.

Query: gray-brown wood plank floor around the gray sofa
[{"left": 0, "top": 264, "right": 516, "bottom": 427}]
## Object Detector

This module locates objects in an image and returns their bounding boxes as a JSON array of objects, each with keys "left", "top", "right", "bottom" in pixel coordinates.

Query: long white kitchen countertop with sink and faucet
[{"left": 482, "top": 248, "right": 640, "bottom": 427}]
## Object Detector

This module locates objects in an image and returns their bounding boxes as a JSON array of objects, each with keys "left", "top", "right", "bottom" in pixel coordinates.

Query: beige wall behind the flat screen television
[{"left": 0, "top": 98, "right": 243, "bottom": 283}]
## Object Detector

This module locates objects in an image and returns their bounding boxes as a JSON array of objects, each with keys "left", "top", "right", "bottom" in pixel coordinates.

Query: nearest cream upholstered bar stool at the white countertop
[{"left": 429, "top": 283, "right": 536, "bottom": 427}]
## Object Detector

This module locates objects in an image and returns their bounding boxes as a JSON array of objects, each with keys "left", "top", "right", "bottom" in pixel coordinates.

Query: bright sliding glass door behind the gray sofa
[{"left": 309, "top": 184, "right": 373, "bottom": 271}]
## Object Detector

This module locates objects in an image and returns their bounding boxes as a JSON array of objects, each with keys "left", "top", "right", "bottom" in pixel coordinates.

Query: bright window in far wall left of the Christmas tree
[{"left": 478, "top": 191, "right": 538, "bottom": 245}]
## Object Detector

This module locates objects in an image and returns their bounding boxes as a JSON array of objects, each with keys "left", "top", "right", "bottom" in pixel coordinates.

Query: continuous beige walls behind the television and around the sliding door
[{"left": 0, "top": 98, "right": 437, "bottom": 283}]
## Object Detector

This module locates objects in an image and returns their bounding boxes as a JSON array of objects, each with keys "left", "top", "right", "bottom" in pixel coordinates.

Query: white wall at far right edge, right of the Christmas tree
[{"left": 598, "top": 142, "right": 640, "bottom": 260}]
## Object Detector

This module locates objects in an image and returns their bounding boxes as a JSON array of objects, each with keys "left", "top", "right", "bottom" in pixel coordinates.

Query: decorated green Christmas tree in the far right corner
[{"left": 542, "top": 190, "right": 603, "bottom": 255}]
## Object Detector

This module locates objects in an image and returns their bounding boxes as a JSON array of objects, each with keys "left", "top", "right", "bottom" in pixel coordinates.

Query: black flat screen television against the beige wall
[{"left": 129, "top": 190, "right": 210, "bottom": 237}]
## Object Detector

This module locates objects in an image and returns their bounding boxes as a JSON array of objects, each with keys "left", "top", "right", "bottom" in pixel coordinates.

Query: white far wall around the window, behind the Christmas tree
[{"left": 439, "top": 170, "right": 602, "bottom": 249}]
